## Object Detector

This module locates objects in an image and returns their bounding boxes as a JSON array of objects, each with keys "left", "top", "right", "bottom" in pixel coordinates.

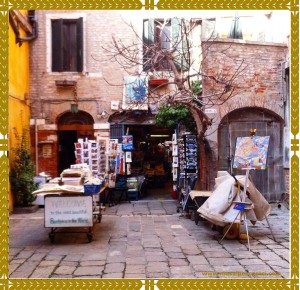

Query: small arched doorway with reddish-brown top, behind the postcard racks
[{"left": 57, "top": 111, "right": 94, "bottom": 174}]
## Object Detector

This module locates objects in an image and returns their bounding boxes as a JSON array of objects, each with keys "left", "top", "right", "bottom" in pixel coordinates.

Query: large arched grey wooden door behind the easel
[{"left": 218, "top": 108, "right": 285, "bottom": 201}]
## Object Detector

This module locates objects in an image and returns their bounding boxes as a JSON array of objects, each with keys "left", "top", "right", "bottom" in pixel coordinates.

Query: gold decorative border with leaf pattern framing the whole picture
[{"left": 0, "top": 0, "right": 299, "bottom": 290}]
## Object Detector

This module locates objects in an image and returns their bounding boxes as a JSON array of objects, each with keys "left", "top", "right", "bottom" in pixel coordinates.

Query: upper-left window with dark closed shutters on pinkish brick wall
[{"left": 51, "top": 18, "right": 83, "bottom": 72}]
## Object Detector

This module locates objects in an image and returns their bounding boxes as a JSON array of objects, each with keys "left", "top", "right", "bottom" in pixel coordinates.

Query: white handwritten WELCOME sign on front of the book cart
[{"left": 45, "top": 194, "right": 93, "bottom": 228}]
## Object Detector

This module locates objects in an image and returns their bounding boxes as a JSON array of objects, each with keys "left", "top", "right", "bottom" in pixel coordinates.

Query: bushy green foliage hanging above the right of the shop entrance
[{"left": 156, "top": 104, "right": 196, "bottom": 130}]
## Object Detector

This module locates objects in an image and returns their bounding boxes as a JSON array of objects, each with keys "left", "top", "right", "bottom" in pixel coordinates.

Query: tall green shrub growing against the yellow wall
[{"left": 10, "top": 128, "right": 38, "bottom": 207}]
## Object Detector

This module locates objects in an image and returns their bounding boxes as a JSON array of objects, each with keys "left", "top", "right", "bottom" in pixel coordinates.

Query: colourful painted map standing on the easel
[{"left": 233, "top": 136, "right": 270, "bottom": 169}]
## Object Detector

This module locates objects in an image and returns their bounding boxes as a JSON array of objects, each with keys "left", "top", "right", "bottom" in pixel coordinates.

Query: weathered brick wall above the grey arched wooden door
[{"left": 202, "top": 39, "right": 287, "bottom": 119}]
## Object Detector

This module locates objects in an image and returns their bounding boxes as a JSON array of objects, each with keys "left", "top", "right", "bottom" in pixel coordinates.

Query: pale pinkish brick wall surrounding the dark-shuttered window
[{"left": 31, "top": 10, "right": 137, "bottom": 124}]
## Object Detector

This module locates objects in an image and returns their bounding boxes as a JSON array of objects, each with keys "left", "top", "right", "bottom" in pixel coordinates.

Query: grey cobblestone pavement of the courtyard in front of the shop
[{"left": 9, "top": 200, "right": 290, "bottom": 279}]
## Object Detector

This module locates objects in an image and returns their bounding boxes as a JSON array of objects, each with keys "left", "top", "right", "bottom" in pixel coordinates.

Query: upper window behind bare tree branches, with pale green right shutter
[{"left": 143, "top": 18, "right": 188, "bottom": 71}]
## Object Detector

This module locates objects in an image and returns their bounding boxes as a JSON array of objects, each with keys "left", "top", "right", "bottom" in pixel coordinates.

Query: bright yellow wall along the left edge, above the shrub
[{"left": 8, "top": 10, "right": 30, "bottom": 210}]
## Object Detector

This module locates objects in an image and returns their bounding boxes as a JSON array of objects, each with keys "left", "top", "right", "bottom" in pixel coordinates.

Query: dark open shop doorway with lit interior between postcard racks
[{"left": 110, "top": 121, "right": 174, "bottom": 200}]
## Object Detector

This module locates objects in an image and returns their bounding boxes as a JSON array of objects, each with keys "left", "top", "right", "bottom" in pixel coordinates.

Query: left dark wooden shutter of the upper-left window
[{"left": 52, "top": 19, "right": 63, "bottom": 72}]
